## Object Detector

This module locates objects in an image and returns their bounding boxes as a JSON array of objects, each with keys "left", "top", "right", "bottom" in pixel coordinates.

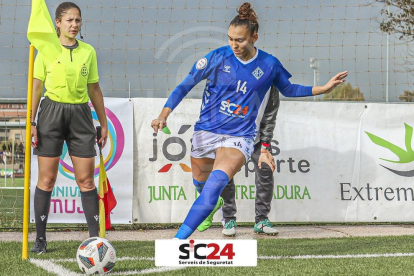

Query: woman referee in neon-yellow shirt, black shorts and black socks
[{"left": 31, "top": 2, "right": 108, "bottom": 254}]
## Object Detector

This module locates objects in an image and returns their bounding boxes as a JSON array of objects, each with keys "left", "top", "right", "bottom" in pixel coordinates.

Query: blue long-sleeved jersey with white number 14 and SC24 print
[{"left": 165, "top": 46, "right": 312, "bottom": 140}]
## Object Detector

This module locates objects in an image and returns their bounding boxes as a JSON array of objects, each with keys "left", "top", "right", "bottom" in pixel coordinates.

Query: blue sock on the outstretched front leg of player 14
[{"left": 175, "top": 170, "right": 229, "bottom": 240}]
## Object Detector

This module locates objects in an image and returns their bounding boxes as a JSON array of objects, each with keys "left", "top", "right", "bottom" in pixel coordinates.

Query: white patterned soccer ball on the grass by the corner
[{"left": 76, "top": 237, "right": 116, "bottom": 274}]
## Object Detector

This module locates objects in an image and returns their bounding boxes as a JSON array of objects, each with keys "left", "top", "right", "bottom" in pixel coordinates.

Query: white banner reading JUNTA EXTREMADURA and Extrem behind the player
[{"left": 133, "top": 99, "right": 414, "bottom": 223}]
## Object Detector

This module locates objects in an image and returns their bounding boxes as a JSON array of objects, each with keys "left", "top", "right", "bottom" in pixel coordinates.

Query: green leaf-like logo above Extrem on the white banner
[{"left": 365, "top": 123, "right": 414, "bottom": 164}]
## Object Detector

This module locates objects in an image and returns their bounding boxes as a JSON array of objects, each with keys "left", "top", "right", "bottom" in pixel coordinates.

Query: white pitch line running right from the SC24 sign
[{"left": 257, "top": 253, "right": 414, "bottom": 260}]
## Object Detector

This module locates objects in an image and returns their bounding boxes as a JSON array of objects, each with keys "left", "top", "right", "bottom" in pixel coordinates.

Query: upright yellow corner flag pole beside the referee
[{"left": 22, "top": 45, "right": 35, "bottom": 260}]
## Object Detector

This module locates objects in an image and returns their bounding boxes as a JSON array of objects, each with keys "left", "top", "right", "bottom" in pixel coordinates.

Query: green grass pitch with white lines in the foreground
[{"left": 0, "top": 236, "right": 414, "bottom": 276}]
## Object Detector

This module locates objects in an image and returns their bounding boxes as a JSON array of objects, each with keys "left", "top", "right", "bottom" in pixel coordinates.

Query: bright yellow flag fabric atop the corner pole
[{"left": 27, "top": 0, "right": 62, "bottom": 62}]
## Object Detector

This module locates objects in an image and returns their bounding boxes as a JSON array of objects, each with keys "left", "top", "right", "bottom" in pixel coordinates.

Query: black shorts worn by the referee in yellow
[{"left": 33, "top": 97, "right": 96, "bottom": 158}]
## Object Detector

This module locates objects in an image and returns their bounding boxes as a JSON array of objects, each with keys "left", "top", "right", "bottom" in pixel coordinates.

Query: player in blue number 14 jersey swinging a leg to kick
[{"left": 151, "top": 3, "right": 347, "bottom": 239}]
